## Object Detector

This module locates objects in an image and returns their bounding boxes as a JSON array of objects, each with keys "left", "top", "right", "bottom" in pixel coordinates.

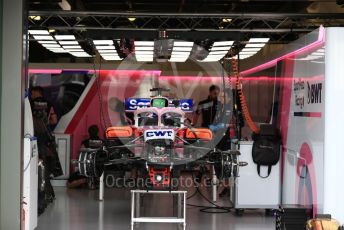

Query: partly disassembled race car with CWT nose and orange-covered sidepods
[{"left": 78, "top": 88, "right": 245, "bottom": 189}]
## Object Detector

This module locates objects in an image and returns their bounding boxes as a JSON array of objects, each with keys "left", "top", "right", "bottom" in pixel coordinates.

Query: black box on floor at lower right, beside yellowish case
[{"left": 276, "top": 205, "right": 311, "bottom": 230}]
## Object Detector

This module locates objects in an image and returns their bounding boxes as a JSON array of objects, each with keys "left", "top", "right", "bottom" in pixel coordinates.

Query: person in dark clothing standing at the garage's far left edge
[{"left": 30, "top": 86, "right": 63, "bottom": 214}]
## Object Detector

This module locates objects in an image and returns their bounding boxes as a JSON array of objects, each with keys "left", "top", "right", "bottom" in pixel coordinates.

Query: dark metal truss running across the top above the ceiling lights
[{"left": 29, "top": 11, "right": 344, "bottom": 41}]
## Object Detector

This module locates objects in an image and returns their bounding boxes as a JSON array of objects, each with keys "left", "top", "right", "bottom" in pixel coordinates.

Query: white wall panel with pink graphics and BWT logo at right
[{"left": 282, "top": 43, "right": 325, "bottom": 216}]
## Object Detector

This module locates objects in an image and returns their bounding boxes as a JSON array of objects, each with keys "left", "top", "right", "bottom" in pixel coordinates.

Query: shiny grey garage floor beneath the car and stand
[{"left": 37, "top": 187, "right": 275, "bottom": 230}]
